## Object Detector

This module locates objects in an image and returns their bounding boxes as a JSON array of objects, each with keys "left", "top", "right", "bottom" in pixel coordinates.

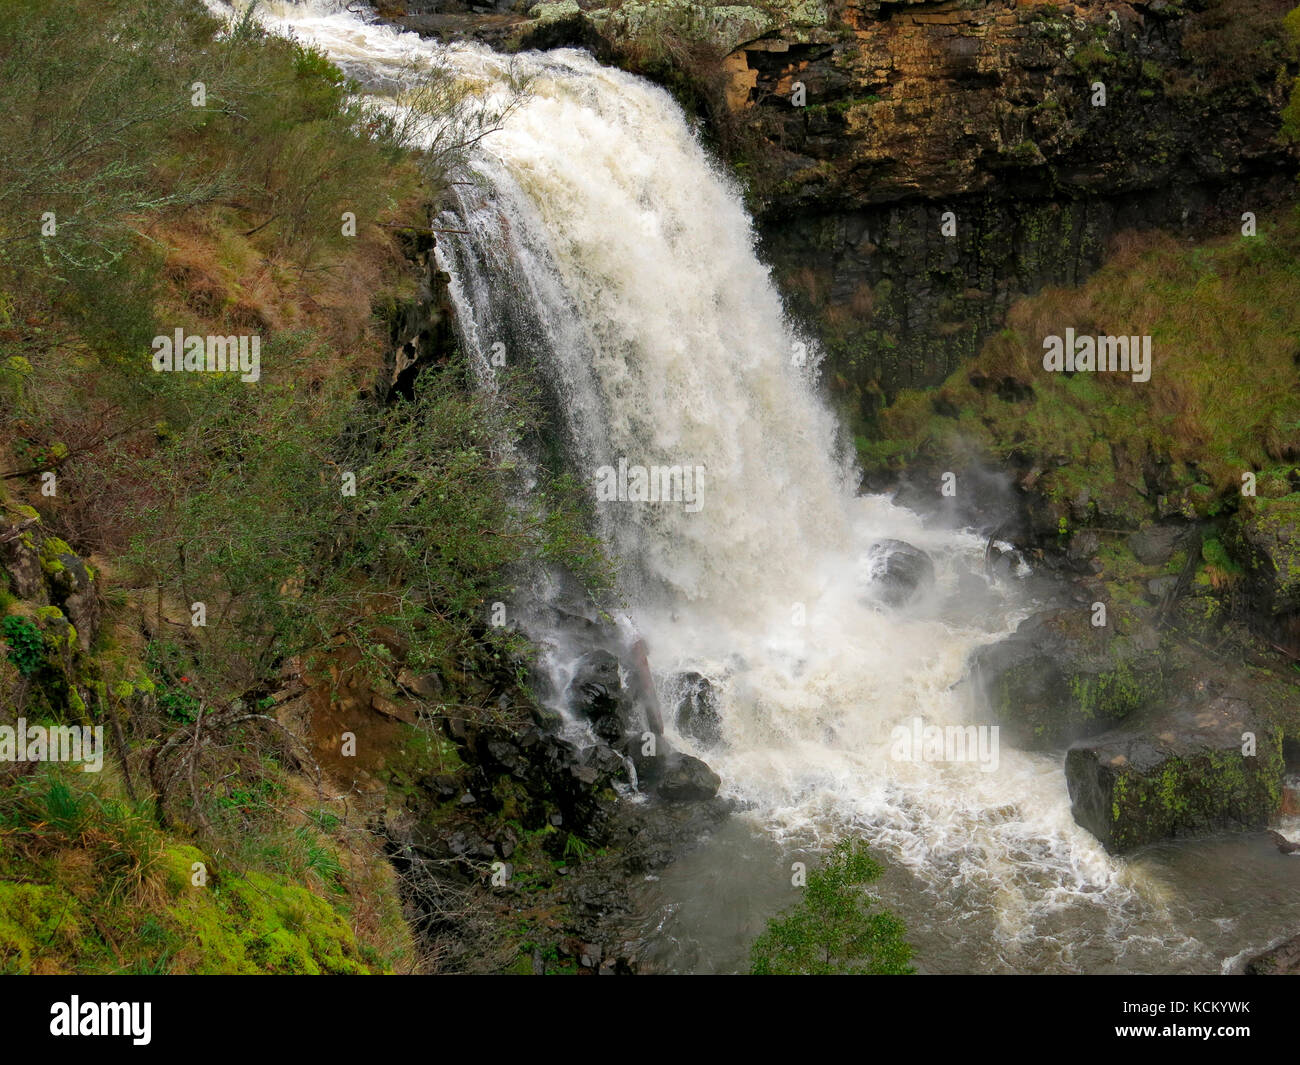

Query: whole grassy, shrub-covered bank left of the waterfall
[{"left": 0, "top": 0, "right": 605, "bottom": 973}]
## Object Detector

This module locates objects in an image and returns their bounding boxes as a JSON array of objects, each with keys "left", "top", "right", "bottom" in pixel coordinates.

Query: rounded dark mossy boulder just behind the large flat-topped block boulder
[{"left": 972, "top": 605, "right": 1165, "bottom": 750}]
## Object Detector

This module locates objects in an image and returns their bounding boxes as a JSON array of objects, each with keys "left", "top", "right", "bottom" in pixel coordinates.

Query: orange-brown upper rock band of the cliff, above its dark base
[{"left": 725, "top": 0, "right": 1291, "bottom": 211}]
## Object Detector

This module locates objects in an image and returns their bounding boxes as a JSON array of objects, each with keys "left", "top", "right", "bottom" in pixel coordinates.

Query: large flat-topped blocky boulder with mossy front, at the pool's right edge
[{"left": 1065, "top": 694, "right": 1284, "bottom": 853}]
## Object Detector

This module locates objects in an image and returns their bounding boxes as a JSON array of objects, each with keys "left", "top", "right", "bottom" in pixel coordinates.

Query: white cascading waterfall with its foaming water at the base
[{"left": 215, "top": 3, "right": 1300, "bottom": 969}]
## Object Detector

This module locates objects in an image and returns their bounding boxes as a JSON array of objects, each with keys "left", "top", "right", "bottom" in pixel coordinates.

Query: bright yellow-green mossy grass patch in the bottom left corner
[{"left": 0, "top": 766, "right": 397, "bottom": 974}]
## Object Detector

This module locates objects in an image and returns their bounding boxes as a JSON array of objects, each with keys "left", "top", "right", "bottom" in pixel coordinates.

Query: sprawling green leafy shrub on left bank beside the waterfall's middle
[{"left": 124, "top": 358, "right": 611, "bottom": 696}]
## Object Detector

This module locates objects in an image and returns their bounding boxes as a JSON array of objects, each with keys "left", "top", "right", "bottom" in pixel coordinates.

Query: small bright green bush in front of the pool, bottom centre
[{"left": 750, "top": 840, "right": 915, "bottom": 977}]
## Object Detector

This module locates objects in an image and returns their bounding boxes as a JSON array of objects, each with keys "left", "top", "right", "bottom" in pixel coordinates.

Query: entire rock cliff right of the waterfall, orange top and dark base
[{"left": 444, "top": 0, "right": 1294, "bottom": 405}]
